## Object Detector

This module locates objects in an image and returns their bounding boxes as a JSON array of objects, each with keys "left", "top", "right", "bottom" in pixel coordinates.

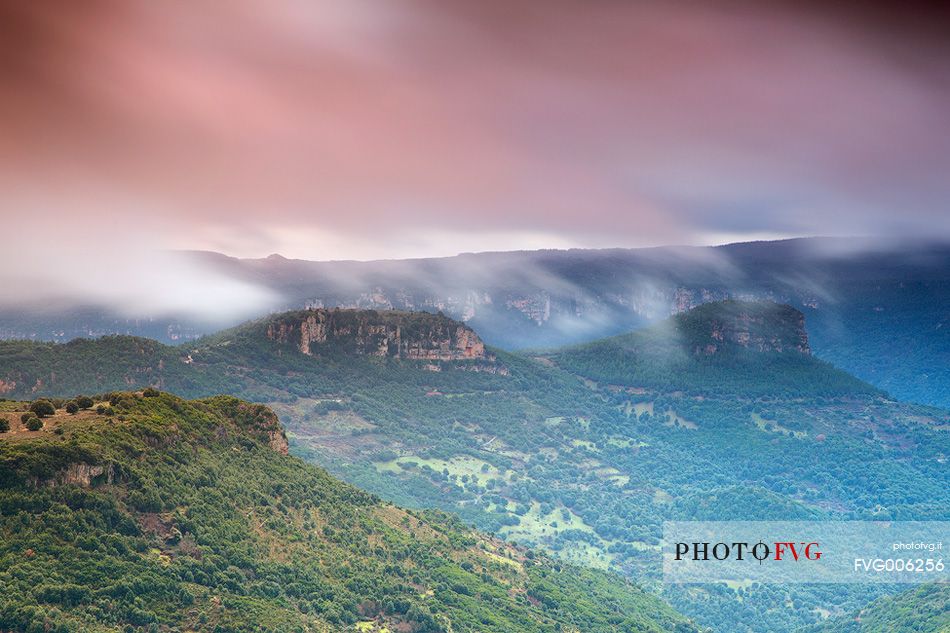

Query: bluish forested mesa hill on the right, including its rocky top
[{"left": 541, "top": 301, "right": 880, "bottom": 397}]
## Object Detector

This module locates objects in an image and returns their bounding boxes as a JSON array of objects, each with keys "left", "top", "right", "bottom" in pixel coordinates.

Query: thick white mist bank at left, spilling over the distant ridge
[{"left": 0, "top": 207, "right": 278, "bottom": 327}]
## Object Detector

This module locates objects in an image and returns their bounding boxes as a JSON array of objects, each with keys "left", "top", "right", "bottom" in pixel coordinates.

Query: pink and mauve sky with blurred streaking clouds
[{"left": 0, "top": 0, "right": 950, "bottom": 292}]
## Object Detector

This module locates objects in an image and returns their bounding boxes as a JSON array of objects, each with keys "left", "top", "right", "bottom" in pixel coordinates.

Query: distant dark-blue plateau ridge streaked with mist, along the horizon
[{"left": 0, "top": 238, "right": 950, "bottom": 407}]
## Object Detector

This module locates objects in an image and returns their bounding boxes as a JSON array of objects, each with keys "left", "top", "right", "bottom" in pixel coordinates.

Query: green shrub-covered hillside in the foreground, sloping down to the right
[{"left": 0, "top": 390, "right": 697, "bottom": 633}]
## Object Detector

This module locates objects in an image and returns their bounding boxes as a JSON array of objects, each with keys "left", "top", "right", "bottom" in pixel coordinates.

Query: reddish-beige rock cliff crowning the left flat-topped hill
[{"left": 266, "top": 309, "right": 486, "bottom": 361}]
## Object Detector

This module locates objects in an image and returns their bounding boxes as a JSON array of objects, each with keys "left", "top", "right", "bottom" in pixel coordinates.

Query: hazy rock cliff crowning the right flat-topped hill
[{"left": 676, "top": 301, "right": 811, "bottom": 356}]
